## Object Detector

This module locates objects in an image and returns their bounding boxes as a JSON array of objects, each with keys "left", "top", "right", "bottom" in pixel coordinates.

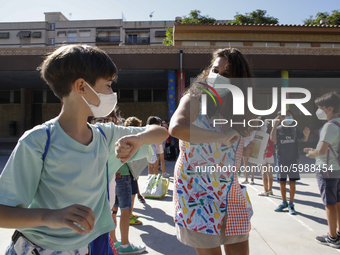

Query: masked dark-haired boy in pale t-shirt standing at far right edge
[{"left": 304, "top": 92, "right": 340, "bottom": 249}]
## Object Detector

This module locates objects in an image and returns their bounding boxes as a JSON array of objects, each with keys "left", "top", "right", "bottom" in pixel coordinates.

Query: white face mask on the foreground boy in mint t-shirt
[{"left": 82, "top": 82, "right": 117, "bottom": 118}]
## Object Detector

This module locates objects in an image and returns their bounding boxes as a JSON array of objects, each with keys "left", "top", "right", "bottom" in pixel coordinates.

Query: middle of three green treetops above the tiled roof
[{"left": 231, "top": 9, "right": 279, "bottom": 24}]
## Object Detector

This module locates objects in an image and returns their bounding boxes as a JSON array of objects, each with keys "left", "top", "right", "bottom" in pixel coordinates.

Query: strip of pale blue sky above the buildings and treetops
[{"left": 0, "top": 0, "right": 340, "bottom": 24}]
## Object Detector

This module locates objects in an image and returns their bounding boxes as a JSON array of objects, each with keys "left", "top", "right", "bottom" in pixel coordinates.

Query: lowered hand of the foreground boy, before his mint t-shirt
[{"left": 44, "top": 204, "right": 95, "bottom": 235}]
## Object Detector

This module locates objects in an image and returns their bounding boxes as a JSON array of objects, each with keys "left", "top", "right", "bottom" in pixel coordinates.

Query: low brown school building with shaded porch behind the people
[{"left": 0, "top": 17, "right": 340, "bottom": 143}]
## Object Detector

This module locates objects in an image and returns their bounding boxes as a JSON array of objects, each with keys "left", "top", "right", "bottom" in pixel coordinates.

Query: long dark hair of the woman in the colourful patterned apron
[{"left": 186, "top": 48, "right": 255, "bottom": 136}]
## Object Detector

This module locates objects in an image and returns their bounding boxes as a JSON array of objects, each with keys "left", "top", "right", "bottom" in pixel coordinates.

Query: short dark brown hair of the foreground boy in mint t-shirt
[{"left": 38, "top": 45, "right": 118, "bottom": 99}]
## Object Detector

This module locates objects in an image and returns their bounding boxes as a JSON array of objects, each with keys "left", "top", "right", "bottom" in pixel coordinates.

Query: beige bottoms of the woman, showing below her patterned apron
[{"left": 176, "top": 213, "right": 249, "bottom": 249}]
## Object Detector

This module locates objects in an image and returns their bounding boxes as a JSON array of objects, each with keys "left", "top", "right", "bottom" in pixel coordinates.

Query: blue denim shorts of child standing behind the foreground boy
[{"left": 113, "top": 175, "right": 132, "bottom": 211}]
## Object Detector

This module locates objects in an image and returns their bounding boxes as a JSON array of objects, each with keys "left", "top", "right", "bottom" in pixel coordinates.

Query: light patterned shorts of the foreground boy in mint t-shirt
[{"left": 5, "top": 236, "right": 89, "bottom": 255}]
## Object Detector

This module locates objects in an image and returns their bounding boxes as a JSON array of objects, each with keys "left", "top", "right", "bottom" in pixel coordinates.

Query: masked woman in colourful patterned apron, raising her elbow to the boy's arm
[{"left": 169, "top": 48, "right": 253, "bottom": 255}]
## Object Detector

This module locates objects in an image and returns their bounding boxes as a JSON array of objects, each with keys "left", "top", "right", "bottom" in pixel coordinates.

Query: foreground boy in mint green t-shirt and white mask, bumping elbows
[{"left": 0, "top": 45, "right": 168, "bottom": 255}]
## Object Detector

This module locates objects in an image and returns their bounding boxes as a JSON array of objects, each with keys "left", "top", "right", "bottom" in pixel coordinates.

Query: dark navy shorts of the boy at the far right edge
[{"left": 316, "top": 171, "right": 340, "bottom": 205}]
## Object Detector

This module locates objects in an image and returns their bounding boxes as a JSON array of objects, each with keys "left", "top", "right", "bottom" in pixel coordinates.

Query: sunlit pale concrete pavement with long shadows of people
[{"left": 0, "top": 157, "right": 340, "bottom": 255}]
